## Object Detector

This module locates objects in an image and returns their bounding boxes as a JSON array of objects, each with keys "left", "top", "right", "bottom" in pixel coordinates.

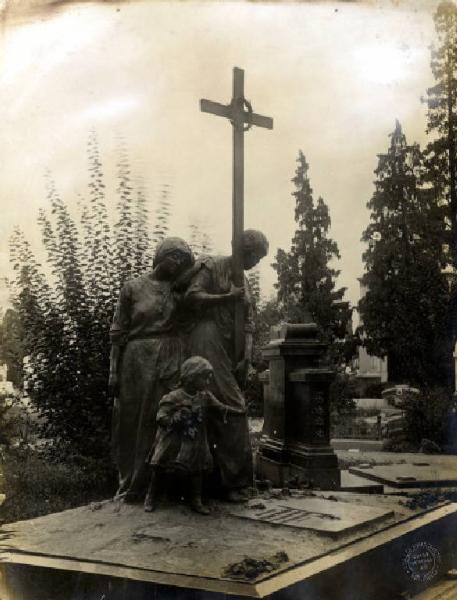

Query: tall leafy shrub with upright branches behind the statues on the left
[{"left": 10, "top": 132, "right": 159, "bottom": 456}]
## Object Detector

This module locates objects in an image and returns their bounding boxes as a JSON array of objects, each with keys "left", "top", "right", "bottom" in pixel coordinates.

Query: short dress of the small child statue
[{"left": 149, "top": 388, "right": 225, "bottom": 473}]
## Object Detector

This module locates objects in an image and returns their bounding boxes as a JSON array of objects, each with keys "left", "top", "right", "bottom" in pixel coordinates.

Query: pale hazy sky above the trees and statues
[{"left": 0, "top": 0, "right": 442, "bottom": 305}]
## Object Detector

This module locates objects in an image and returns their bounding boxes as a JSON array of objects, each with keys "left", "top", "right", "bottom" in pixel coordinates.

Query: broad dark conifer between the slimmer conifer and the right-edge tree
[{"left": 359, "top": 122, "right": 448, "bottom": 385}]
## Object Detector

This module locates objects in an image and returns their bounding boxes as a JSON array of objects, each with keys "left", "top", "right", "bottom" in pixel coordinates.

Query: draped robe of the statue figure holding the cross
[{"left": 186, "top": 256, "right": 253, "bottom": 489}]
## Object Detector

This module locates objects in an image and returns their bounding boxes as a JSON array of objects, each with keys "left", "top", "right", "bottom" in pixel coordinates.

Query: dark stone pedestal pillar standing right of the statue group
[{"left": 257, "top": 323, "right": 341, "bottom": 490}]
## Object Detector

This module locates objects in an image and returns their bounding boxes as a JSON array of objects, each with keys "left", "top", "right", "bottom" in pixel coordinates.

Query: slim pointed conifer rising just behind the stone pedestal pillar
[{"left": 273, "top": 151, "right": 351, "bottom": 362}]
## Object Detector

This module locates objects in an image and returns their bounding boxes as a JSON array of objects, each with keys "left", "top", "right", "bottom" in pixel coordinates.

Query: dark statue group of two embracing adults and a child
[{"left": 109, "top": 229, "right": 268, "bottom": 514}]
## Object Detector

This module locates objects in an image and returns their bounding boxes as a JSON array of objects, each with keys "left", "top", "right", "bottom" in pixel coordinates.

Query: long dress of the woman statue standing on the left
[{"left": 110, "top": 274, "right": 184, "bottom": 496}]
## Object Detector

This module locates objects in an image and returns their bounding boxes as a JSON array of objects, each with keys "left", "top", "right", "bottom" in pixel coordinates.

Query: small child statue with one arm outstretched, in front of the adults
[{"left": 144, "top": 356, "right": 245, "bottom": 515}]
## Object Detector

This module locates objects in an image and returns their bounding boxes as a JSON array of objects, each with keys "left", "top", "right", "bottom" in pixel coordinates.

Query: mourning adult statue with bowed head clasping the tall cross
[{"left": 185, "top": 229, "right": 268, "bottom": 502}]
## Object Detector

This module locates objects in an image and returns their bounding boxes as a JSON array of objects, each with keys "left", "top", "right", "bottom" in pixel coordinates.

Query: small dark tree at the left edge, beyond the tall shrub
[{"left": 0, "top": 308, "right": 24, "bottom": 388}]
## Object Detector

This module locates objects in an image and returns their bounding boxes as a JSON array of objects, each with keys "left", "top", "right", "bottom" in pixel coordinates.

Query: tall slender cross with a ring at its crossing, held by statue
[{"left": 200, "top": 67, "right": 273, "bottom": 364}]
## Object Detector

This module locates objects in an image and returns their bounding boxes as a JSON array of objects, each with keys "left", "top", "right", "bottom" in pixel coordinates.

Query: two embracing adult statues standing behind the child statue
[{"left": 109, "top": 229, "right": 268, "bottom": 505}]
